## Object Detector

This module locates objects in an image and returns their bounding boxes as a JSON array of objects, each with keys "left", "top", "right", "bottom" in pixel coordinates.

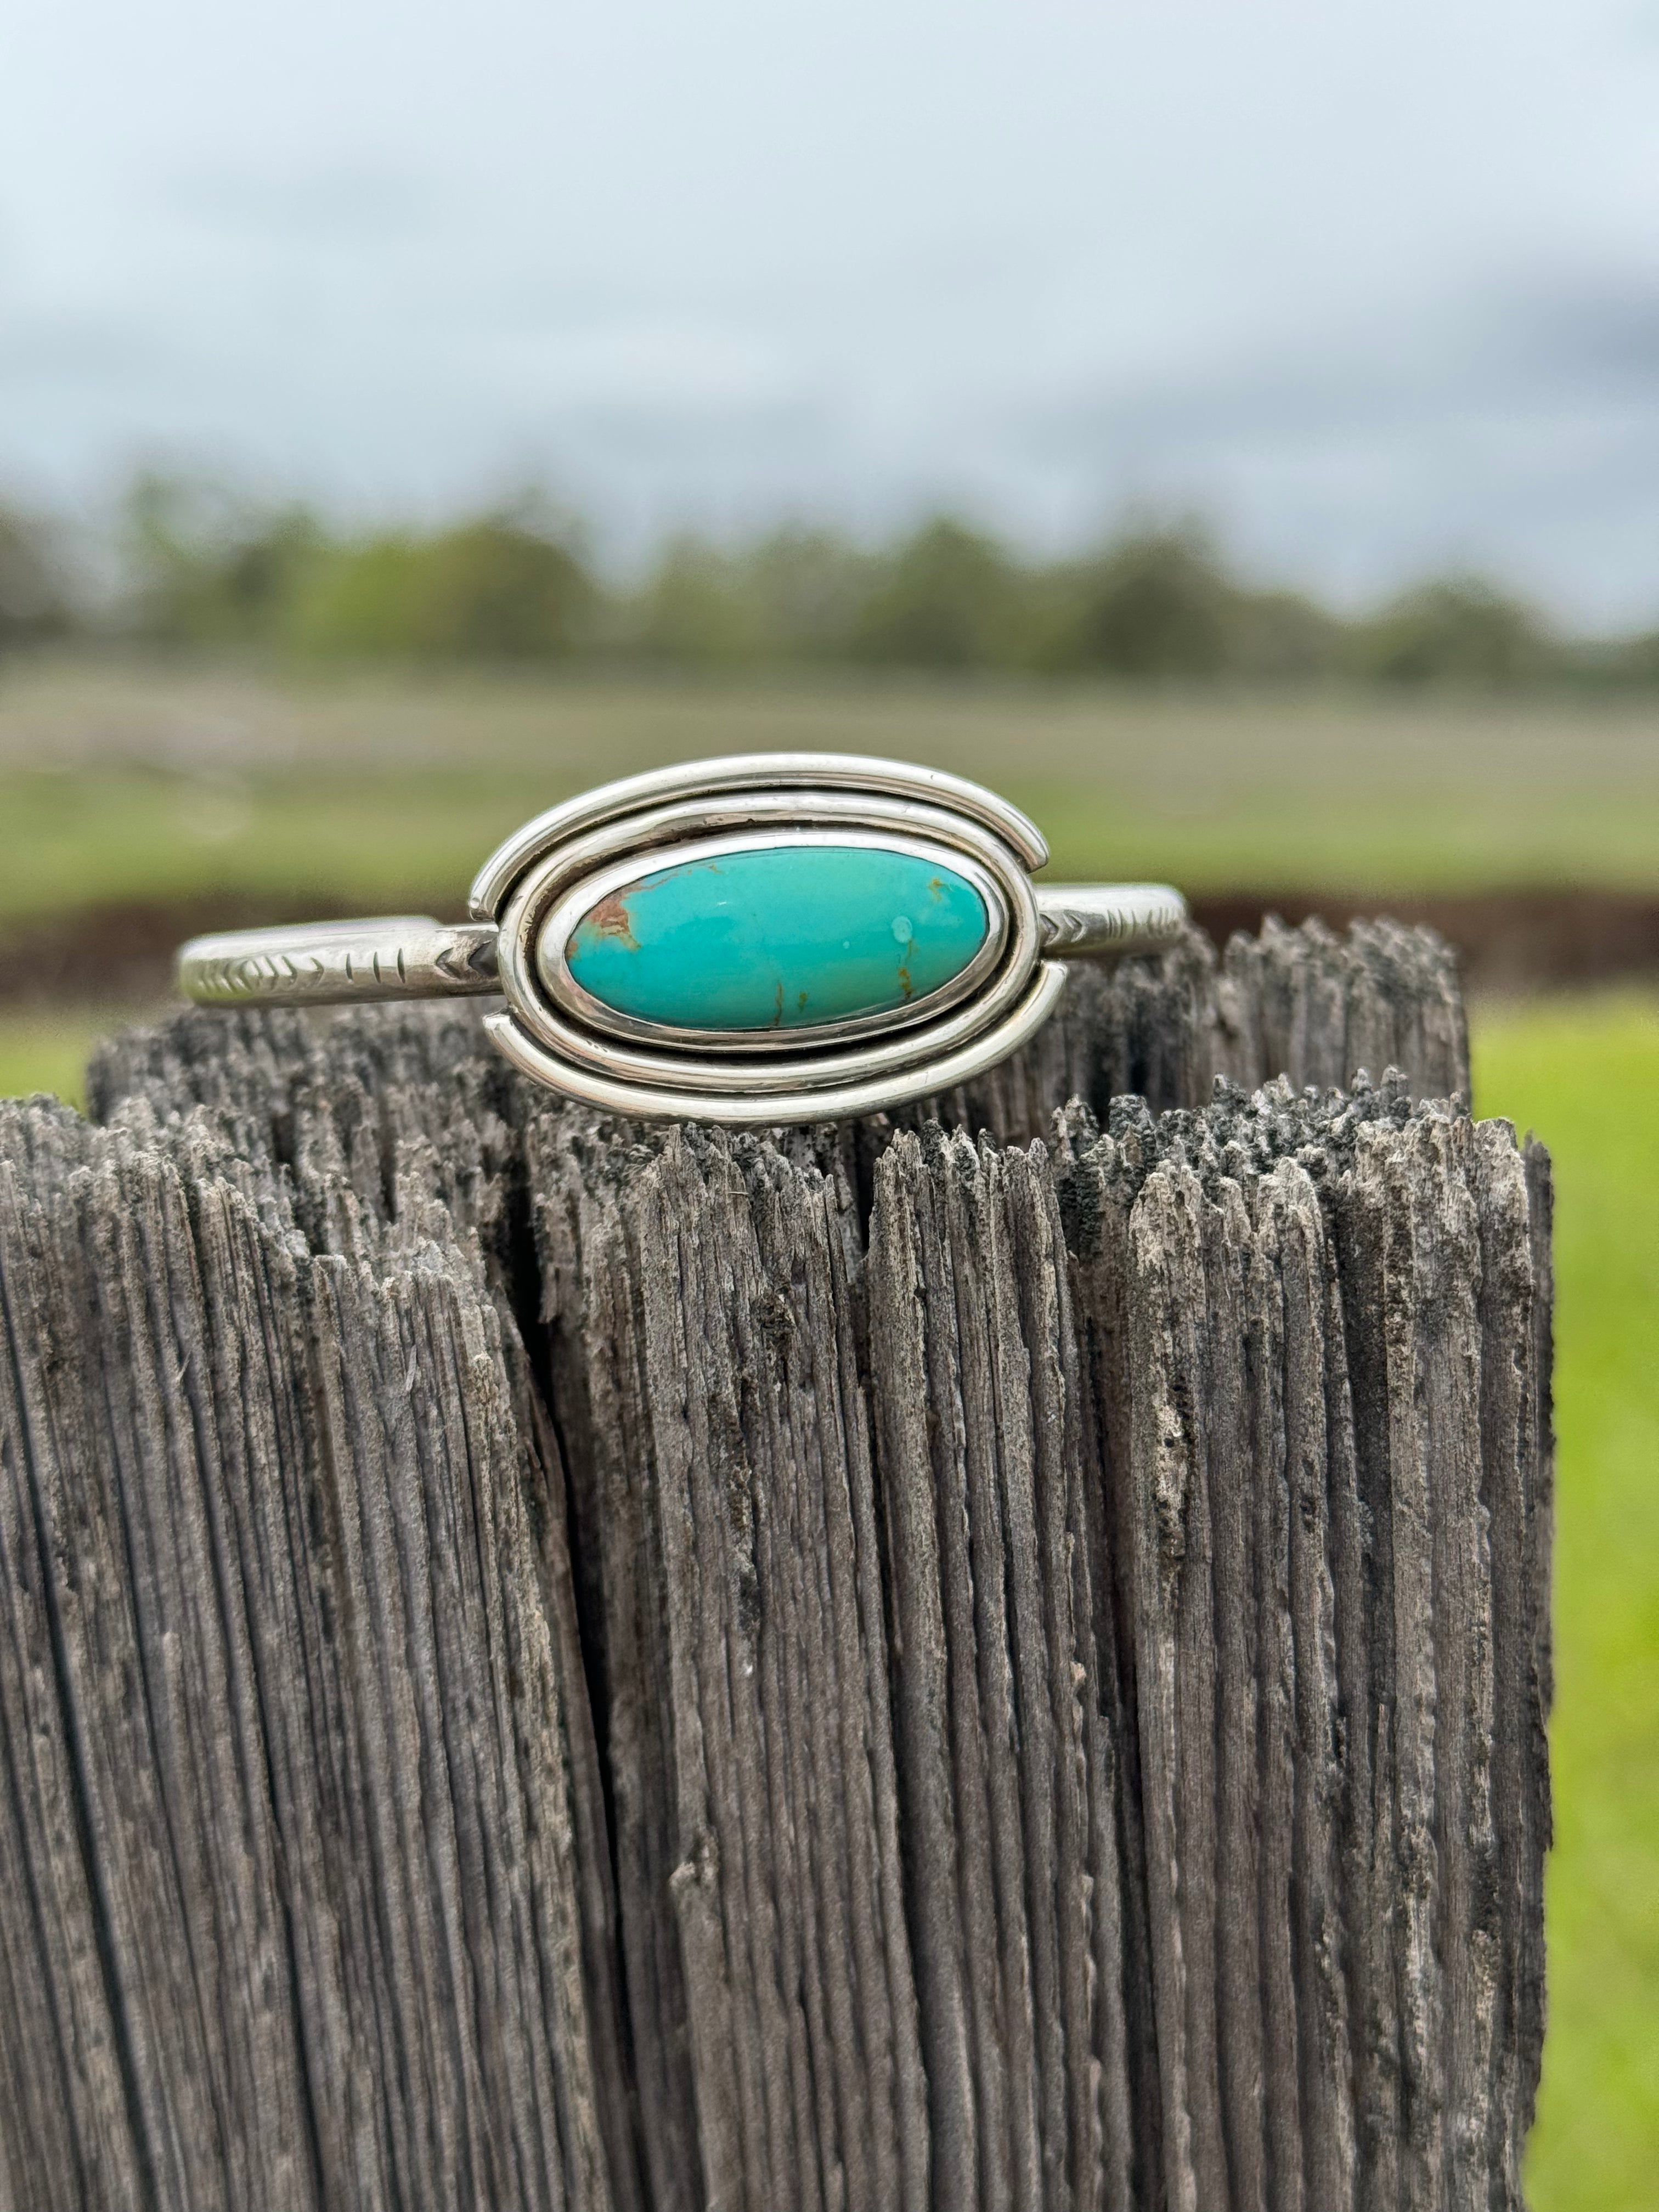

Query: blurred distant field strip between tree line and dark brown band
[{"left": 0, "top": 664, "right": 1659, "bottom": 918}]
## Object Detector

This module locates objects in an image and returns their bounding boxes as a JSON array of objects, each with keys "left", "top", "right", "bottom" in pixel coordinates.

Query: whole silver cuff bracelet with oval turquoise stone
[{"left": 179, "top": 752, "right": 1186, "bottom": 1126}]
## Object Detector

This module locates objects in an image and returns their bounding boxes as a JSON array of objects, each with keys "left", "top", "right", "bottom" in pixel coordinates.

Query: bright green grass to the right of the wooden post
[{"left": 1471, "top": 995, "right": 1659, "bottom": 2212}]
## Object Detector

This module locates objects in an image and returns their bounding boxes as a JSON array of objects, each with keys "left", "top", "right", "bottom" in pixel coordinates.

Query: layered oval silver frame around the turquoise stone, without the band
[{"left": 473, "top": 754, "right": 1064, "bottom": 1126}]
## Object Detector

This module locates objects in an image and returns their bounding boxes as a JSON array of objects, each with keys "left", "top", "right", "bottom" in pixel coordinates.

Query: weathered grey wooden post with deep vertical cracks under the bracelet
[{"left": 0, "top": 924, "right": 1550, "bottom": 2212}]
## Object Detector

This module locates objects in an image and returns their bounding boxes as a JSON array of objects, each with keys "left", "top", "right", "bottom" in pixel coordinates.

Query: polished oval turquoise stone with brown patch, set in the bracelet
[{"left": 564, "top": 845, "right": 991, "bottom": 1031}]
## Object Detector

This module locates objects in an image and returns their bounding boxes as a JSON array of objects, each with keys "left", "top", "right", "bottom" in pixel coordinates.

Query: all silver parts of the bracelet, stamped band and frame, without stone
[{"left": 179, "top": 752, "right": 1186, "bottom": 1126}]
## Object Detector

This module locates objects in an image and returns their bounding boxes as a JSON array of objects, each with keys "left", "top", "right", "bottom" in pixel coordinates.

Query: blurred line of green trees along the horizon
[{"left": 0, "top": 476, "right": 1659, "bottom": 690}]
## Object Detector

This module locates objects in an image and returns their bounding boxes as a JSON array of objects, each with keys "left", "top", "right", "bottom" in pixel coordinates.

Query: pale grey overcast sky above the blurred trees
[{"left": 0, "top": 0, "right": 1659, "bottom": 624}]
